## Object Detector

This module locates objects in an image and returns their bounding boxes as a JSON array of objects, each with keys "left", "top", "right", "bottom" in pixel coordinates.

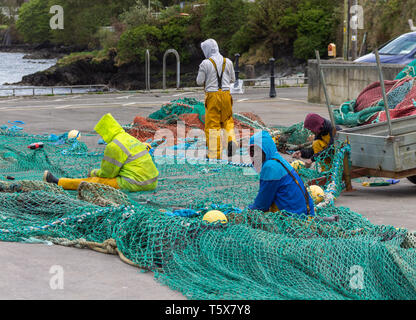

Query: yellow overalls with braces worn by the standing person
[{"left": 205, "top": 58, "right": 236, "bottom": 159}]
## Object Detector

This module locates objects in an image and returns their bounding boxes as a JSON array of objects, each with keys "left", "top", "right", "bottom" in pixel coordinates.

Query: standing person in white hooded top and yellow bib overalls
[{"left": 196, "top": 39, "right": 237, "bottom": 159}]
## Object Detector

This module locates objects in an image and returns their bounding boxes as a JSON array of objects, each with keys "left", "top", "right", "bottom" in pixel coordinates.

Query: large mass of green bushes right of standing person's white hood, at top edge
[{"left": 230, "top": 0, "right": 340, "bottom": 64}]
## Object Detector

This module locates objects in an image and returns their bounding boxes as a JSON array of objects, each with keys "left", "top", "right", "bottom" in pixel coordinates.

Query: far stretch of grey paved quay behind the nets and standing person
[{"left": 0, "top": 88, "right": 326, "bottom": 133}]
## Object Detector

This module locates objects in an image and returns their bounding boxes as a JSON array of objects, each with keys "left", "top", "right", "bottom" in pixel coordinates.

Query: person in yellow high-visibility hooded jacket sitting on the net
[{"left": 43, "top": 113, "right": 159, "bottom": 192}]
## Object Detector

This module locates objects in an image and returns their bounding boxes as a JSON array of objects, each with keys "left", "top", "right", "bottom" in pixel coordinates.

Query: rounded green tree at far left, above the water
[{"left": 16, "top": 0, "right": 51, "bottom": 43}]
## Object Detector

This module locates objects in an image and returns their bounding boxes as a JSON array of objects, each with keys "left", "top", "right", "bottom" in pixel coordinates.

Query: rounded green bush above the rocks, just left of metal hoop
[{"left": 117, "top": 25, "right": 162, "bottom": 64}]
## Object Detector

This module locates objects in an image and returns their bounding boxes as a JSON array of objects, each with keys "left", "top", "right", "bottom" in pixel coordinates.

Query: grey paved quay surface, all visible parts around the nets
[{"left": 0, "top": 88, "right": 416, "bottom": 300}]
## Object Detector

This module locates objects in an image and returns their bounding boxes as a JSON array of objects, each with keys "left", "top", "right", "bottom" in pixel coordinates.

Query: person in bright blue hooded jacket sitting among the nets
[{"left": 249, "top": 131, "right": 315, "bottom": 217}]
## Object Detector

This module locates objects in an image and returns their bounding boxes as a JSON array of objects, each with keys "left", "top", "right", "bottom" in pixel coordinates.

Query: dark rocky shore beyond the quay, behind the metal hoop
[{"left": 6, "top": 47, "right": 305, "bottom": 90}]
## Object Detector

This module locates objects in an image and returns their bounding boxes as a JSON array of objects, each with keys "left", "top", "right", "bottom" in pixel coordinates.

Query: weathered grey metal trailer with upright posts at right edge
[{"left": 316, "top": 50, "right": 416, "bottom": 186}]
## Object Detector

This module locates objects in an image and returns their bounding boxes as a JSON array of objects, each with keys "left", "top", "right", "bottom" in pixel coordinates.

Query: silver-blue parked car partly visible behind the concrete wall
[{"left": 354, "top": 32, "right": 416, "bottom": 65}]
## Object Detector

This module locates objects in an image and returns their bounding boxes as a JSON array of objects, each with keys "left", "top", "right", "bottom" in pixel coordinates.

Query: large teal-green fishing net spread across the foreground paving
[{"left": 0, "top": 123, "right": 416, "bottom": 300}]
